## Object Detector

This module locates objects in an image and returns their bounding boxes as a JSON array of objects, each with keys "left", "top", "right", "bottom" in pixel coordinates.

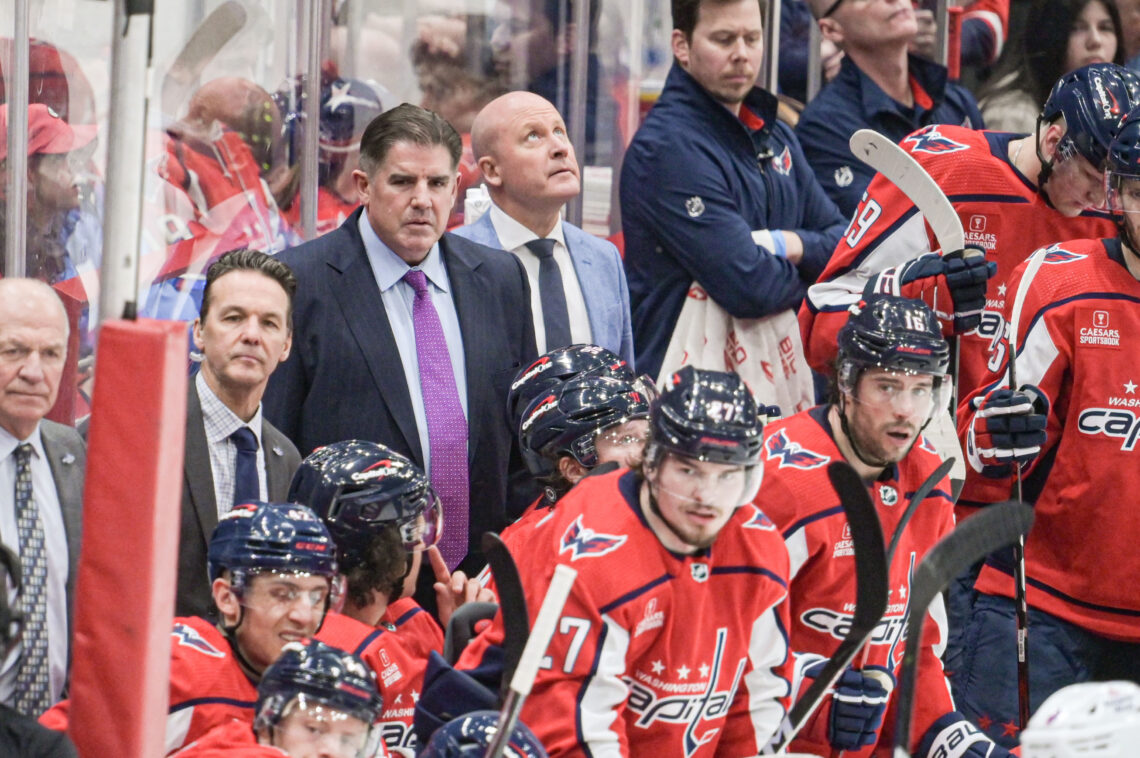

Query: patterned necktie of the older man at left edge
[{"left": 13, "top": 442, "right": 51, "bottom": 717}]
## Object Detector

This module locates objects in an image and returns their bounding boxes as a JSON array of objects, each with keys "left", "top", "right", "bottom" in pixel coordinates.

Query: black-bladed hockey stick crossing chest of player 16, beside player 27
[{"left": 762, "top": 460, "right": 888, "bottom": 755}]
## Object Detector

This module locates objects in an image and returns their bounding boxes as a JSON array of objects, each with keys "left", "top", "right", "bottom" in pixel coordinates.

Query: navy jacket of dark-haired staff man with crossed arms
[{"left": 621, "top": 63, "right": 846, "bottom": 376}]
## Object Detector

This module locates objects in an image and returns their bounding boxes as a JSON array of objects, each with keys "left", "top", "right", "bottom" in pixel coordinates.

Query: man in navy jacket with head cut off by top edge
[{"left": 796, "top": 0, "right": 982, "bottom": 217}]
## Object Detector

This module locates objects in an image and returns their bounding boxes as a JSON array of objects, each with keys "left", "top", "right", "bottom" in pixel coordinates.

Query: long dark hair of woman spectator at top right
[{"left": 978, "top": 0, "right": 1124, "bottom": 112}]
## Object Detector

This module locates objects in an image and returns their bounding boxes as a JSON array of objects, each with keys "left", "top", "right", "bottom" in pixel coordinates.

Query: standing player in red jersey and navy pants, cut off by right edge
[{"left": 953, "top": 103, "right": 1140, "bottom": 747}]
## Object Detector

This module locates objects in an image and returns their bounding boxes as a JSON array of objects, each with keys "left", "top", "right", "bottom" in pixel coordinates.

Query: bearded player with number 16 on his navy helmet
[{"left": 756, "top": 295, "right": 1008, "bottom": 758}]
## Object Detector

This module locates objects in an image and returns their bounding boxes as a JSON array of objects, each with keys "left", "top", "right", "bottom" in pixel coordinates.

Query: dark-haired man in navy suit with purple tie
[{"left": 266, "top": 104, "right": 536, "bottom": 579}]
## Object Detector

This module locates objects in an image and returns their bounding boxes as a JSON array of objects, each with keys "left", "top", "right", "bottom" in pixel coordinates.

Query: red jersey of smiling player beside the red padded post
[{"left": 40, "top": 617, "right": 258, "bottom": 755}]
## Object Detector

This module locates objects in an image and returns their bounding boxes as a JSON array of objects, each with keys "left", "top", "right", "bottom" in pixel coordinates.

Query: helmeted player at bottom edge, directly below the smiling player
[{"left": 177, "top": 639, "right": 385, "bottom": 758}]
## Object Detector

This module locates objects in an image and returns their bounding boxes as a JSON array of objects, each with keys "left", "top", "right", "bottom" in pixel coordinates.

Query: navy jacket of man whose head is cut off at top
[{"left": 796, "top": 55, "right": 983, "bottom": 218}]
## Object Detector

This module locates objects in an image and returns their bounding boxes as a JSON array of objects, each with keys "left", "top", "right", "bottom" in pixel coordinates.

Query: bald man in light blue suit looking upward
[{"left": 455, "top": 91, "right": 634, "bottom": 366}]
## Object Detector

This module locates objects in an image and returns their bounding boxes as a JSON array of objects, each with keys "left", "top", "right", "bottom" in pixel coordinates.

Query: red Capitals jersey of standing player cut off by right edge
[{"left": 959, "top": 239, "right": 1140, "bottom": 643}]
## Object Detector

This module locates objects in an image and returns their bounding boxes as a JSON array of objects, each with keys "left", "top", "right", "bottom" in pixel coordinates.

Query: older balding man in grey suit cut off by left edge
[{"left": 0, "top": 279, "right": 87, "bottom": 716}]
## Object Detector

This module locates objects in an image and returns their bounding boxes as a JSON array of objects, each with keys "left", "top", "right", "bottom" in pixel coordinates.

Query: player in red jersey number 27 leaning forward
[{"left": 457, "top": 366, "right": 791, "bottom": 758}]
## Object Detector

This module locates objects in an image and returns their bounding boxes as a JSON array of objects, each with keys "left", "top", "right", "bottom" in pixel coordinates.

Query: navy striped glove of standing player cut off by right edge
[{"left": 966, "top": 384, "right": 1049, "bottom": 479}]
